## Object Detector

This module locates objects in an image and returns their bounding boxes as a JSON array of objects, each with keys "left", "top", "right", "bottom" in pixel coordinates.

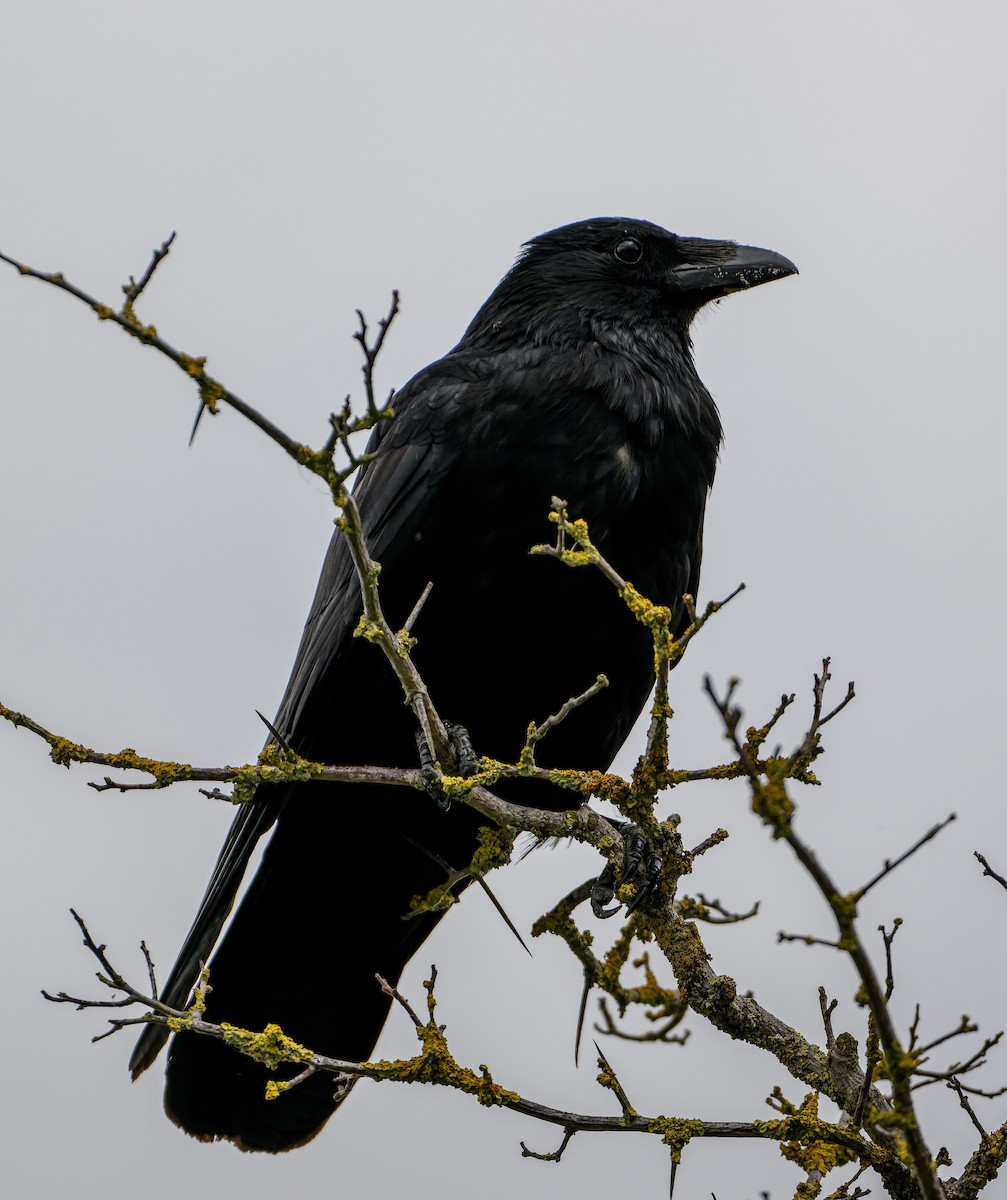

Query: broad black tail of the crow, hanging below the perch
[{"left": 164, "top": 785, "right": 478, "bottom": 1152}]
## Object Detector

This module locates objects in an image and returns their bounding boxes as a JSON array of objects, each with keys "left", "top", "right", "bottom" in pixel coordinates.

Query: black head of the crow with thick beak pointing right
[{"left": 467, "top": 217, "right": 797, "bottom": 342}]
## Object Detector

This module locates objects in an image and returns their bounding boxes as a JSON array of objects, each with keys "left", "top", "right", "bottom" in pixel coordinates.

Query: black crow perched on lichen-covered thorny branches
[{"left": 130, "top": 217, "right": 797, "bottom": 1153}]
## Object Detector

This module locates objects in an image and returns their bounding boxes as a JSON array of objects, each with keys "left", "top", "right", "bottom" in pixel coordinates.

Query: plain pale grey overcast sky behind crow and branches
[{"left": 0, "top": 0, "right": 1007, "bottom": 1200}]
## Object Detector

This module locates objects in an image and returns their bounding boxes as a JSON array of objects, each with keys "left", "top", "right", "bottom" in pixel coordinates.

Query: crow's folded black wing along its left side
[{"left": 130, "top": 360, "right": 472, "bottom": 1079}]
